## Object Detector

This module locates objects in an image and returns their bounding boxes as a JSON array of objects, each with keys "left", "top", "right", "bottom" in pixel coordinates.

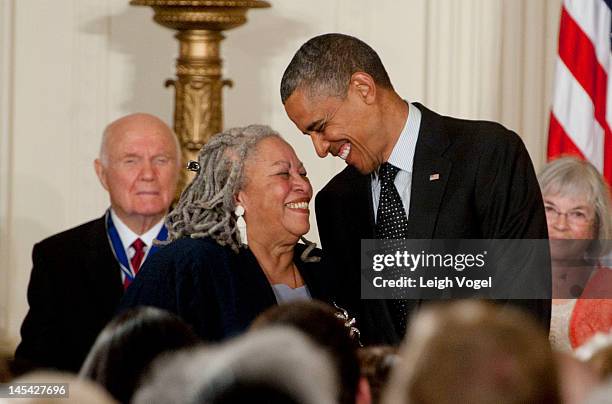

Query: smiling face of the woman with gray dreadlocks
[{"left": 236, "top": 137, "right": 312, "bottom": 244}]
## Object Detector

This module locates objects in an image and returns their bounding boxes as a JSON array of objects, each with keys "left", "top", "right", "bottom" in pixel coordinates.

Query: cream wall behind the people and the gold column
[{"left": 0, "top": 0, "right": 560, "bottom": 349}]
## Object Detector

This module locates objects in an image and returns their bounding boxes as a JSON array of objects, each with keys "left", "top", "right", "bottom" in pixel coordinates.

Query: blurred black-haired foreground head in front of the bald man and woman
[{"left": 79, "top": 307, "right": 199, "bottom": 402}]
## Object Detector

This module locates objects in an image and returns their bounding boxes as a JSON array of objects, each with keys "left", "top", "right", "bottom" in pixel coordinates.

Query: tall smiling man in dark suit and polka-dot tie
[{"left": 281, "top": 34, "right": 550, "bottom": 343}]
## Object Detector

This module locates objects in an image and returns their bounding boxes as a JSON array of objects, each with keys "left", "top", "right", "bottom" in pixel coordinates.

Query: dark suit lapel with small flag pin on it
[{"left": 408, "top": 103, "right": 452, "bottom": 239}]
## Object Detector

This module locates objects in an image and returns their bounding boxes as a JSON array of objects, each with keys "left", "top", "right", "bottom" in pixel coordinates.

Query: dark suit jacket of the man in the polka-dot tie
[{"left": 315, "top": 104, "right": 550, "bottom": 344}]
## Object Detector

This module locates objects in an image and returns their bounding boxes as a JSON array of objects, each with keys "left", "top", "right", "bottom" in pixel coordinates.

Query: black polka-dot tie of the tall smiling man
[{"left": 375, "top": 163, "right": 411, "bottom": 338}]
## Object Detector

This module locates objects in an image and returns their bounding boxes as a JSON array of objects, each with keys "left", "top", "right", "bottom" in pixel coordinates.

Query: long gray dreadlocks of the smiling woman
[{"left": 161, "top": 125, "right": 318, "bottom": 261}]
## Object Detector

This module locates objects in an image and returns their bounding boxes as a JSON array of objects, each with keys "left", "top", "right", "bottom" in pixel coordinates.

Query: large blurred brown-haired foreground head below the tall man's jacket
[{"left": 383, "top": 301, "right": 560, "bottom": 404}]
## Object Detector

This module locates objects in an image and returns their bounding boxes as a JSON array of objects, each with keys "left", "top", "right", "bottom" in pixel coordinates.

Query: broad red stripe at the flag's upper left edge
[{"left": 559, "top": 7, "right": 610, "bottom": 132}]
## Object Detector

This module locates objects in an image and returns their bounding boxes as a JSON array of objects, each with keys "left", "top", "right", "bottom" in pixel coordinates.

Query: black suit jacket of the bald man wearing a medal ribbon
[{"left": 15, "top": 217, "right": 123, "bottom": 372}]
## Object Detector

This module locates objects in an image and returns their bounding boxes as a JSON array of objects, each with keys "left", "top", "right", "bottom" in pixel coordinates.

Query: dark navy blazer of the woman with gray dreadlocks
[{"left": 120, "top": 238, "right": 331, "bottom": 341}]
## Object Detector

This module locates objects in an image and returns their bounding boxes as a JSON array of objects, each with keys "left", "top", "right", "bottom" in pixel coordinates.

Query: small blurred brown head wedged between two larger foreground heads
[{"left": 357, "top": 346, "right": 399, "bottom": 404}]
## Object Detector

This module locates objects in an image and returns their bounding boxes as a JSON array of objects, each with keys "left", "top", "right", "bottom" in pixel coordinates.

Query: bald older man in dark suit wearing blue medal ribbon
[{"left": 15, "top": 114, "right": 180, "bottom": 372}]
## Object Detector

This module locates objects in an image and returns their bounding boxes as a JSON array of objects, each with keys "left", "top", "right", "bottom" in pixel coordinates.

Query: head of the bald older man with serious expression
[{"left": 94, "top": 113, "right": 181, "bottom": 231}]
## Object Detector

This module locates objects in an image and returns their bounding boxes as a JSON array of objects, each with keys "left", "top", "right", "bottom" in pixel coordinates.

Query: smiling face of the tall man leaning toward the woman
[{"left": 285, "top": 84, "right": 390, "bottom": 174}]
